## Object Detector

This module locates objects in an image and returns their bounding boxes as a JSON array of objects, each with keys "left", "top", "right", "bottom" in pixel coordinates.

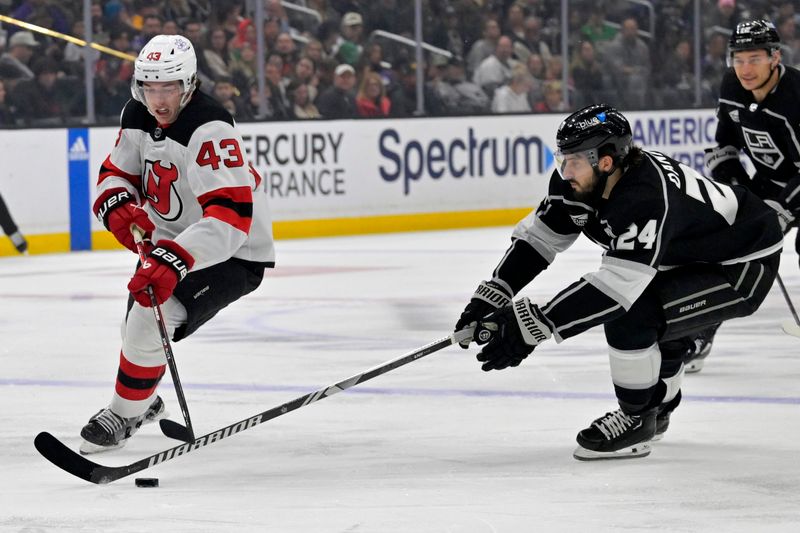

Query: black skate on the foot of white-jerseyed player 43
[{"left": 80, "top": 396, "right": 169, "bottom": 455}]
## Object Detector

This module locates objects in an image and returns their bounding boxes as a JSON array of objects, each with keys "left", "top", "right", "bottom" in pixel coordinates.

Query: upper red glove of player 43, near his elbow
[{"left": 93, "top": 188, "right": 156, "bottom": 253}]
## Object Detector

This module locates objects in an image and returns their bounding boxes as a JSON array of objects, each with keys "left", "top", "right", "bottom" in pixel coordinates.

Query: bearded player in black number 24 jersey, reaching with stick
[{"left": 456, "top": 105, "right": 783, "bottom": 460}]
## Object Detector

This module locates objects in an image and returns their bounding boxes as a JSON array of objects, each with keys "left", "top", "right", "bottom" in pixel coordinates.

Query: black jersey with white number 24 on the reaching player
[{"left": 494, "top": 151, "right": 783, "bottom": 341}]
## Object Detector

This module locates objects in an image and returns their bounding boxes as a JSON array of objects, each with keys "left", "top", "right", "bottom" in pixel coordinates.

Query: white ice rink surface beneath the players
[{"left": 0, "top": 228, "right": 800, "bottom": 533}]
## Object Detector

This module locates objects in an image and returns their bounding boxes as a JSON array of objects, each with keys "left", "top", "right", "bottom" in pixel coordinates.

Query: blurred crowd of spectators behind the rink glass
[{"left": 0, "top": 0, "right": 800, "bottom": 127}]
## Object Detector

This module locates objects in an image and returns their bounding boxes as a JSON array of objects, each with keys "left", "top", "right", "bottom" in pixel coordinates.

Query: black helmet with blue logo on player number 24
[{"left": 555, "top": 104, "right": 633, "bottom": 169}]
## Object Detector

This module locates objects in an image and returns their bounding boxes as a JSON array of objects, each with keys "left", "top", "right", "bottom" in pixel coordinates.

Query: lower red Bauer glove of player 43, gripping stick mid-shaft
[{"left": 128, "top": 240, "right": 194, "bottom": 307}]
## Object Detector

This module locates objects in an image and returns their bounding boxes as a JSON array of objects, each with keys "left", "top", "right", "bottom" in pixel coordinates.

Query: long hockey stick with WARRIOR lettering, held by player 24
[{"left": 33, "top": 328, "right": 474, "bottom": 485}]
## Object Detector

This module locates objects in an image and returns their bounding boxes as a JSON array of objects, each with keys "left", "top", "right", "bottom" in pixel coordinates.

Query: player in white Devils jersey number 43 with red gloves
[{"left": 81, "top": 35, "right": 275, "bottom": 453}]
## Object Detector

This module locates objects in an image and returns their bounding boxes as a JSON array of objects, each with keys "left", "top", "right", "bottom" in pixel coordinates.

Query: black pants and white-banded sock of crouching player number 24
[{"left": 605, "top": 253, "right": 780, "bottom": 413}]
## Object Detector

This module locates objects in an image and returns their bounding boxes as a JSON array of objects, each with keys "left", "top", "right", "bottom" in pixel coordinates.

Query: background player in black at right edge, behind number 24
[{"left": 704, "top": 20, "right": 800, "bottom": 371}]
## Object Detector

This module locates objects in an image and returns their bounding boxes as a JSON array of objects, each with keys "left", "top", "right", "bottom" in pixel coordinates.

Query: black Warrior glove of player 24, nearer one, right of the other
[{"left": 474, "top": 298, "right": 553, "bottom": 372}]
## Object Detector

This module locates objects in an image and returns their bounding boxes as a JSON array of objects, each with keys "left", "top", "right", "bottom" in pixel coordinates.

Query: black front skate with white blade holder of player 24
[{"left": 572, "top": 409, "right": 656, "bottom": 461}]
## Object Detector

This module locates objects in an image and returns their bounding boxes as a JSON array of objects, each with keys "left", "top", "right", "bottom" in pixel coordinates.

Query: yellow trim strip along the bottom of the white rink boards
[{"left": 0, "top": 207, "right": 531, "bottom": 256}]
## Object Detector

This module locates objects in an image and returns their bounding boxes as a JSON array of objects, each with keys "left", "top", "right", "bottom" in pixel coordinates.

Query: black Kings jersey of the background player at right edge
[{"left": 716, "top": 65, "right": 800, "bottom": 198}]
